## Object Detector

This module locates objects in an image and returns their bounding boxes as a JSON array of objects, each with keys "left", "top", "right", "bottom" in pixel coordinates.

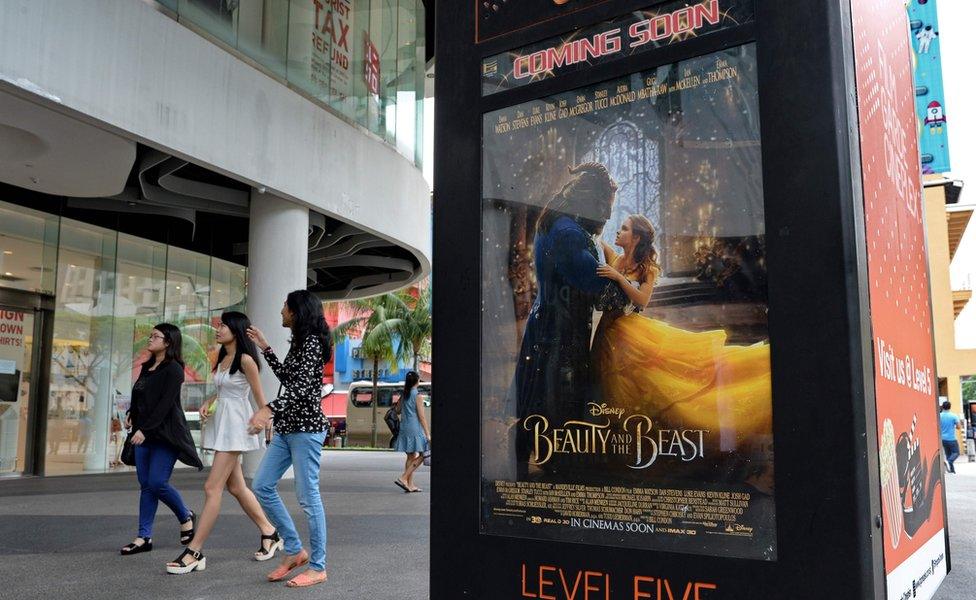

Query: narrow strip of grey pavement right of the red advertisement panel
[{"left": 935, "top": 456, "right": 976, "bottom": 600}]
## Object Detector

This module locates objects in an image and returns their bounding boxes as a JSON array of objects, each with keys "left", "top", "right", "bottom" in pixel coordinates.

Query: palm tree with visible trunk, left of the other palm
[{"left": 332, "top": 294, "right": 404, "bottom": 447}]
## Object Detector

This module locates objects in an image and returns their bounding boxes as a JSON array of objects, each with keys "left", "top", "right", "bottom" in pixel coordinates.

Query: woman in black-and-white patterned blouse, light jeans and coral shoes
[{"left": 247, "top": 290, "right": 332, "bottom": 587}]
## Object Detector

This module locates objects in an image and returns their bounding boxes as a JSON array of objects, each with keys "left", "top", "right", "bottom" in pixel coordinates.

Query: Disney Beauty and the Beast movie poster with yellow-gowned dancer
[{"left": 481, "top": 44, "right": 776, "bottom": 560}]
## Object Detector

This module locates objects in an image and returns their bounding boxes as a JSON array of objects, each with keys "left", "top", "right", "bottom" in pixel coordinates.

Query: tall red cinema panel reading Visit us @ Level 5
[{"left": 852, "top": 0, "right": 946, "bottom": 598}]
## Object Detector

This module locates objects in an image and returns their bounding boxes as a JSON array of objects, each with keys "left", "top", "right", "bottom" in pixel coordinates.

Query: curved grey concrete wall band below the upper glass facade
[{"left": 0, "top": 0, "right": 430, "bottom": 273}]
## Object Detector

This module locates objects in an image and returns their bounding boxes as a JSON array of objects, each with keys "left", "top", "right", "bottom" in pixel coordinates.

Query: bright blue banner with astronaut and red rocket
[{"left": 908, "top": 0, "right": 950, "bottom": 173}]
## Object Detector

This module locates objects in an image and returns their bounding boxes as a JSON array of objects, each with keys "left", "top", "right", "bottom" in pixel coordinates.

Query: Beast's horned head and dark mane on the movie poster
[{"left": 536, "top": 162, "right": 617, "bottom": 234}]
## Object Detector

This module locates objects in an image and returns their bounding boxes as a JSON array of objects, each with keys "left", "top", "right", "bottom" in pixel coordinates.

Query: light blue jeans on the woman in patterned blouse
[{"left": 252, "top": 433, "right": 326, "bottom": 571}]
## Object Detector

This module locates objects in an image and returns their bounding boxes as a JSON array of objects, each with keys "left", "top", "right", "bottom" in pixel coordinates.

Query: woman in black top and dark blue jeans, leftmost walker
[{"left": 120, "top": 323, "right": 203, "bottom": 556}]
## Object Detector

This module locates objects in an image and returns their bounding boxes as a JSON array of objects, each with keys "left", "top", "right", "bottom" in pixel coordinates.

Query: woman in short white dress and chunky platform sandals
[{"left": 166, "top": 312, "right": 283, "bottom": 575}]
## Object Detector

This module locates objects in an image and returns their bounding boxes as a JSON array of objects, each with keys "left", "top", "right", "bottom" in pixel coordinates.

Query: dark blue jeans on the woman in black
[{"left": 135, "top": 440, "right": 190, "bottom": 539}]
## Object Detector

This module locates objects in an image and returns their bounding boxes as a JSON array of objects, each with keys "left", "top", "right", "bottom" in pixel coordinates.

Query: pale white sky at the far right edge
[{"left": 938, "top": 0, "right": 976, "bottom": 350}]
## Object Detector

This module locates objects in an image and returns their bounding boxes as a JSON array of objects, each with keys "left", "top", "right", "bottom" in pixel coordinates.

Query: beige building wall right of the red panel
[{"left": 925, "top": 186, "right": 976, "bottom": 413}]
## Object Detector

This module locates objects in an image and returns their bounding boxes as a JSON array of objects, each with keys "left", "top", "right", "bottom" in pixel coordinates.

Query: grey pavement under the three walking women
[{"left": 0, "top": 451, "right": 430, "bottom": 600}]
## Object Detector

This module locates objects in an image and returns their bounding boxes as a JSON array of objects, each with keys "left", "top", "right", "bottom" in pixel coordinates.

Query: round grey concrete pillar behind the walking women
[{"left": 244, "top": 190, "right": 308, "bottom": 477}]
